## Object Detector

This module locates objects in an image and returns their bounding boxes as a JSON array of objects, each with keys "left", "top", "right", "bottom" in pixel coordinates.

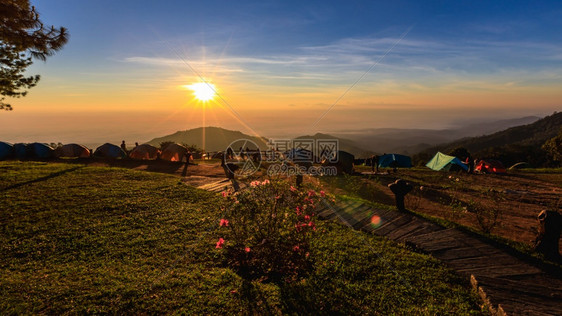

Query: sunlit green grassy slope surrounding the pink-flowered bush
[{"left": 0, "top": 162, "right": 478, "bottom": 314}]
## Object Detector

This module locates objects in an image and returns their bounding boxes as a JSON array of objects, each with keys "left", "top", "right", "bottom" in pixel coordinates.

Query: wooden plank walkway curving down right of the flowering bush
[{"left": 319, "top": 201, "right": 562, "bottom": 315}]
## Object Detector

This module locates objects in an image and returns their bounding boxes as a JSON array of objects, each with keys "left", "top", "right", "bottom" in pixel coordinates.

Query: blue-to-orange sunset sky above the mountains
[{"left": 0, "top": 0, "right": 562, "bottom": 144}]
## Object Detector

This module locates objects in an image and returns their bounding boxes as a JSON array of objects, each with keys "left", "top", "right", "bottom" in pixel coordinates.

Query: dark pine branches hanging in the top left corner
[{"left": 0, "top": 0, "right": 68, "bottom": 110}]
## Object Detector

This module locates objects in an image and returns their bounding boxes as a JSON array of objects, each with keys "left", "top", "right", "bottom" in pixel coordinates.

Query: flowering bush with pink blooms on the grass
[{"left": 216, "top": 180, "right": 325, "bottom": 281}]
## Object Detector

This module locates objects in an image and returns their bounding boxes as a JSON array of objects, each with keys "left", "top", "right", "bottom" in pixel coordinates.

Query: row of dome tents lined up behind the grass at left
[{"left": 0, "top": 142, "right": 188, "bottom": 161}]
